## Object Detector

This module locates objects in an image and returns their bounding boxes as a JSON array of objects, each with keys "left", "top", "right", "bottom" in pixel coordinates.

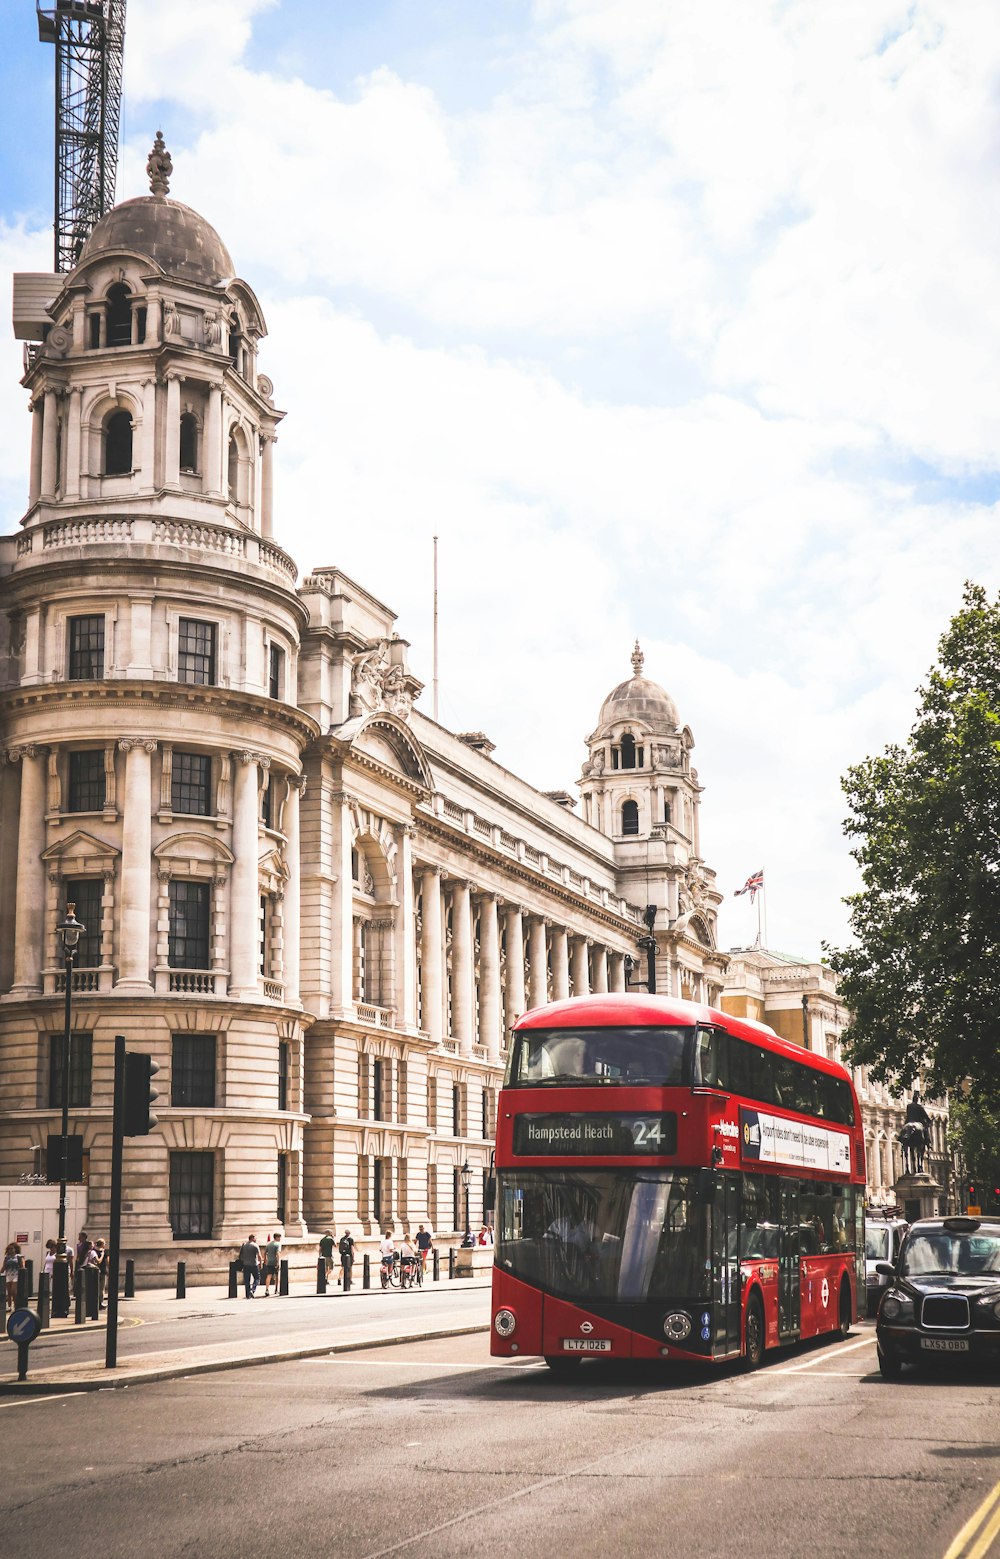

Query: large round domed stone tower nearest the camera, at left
[{"left": 0, "top": 134, "right": 317, "bottom": 1272}]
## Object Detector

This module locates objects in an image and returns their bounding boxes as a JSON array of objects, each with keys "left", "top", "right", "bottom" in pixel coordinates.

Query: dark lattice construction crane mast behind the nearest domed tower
[{"left": 36, "top": 0, "right": 125, "bottom": 271}]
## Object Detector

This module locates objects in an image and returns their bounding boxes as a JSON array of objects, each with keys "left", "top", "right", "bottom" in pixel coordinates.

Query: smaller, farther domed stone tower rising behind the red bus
[{"left": 579, "top": 641, "right": 725, "bottom": 1001}]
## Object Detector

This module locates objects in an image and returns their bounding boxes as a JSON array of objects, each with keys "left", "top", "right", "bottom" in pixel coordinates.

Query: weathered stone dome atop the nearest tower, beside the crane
[{"left": 76, "top": 195, "right": 236, "bottom": 287}]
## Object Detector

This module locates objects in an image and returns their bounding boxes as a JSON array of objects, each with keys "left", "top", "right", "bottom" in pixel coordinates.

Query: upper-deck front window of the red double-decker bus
[{"left": 505, "top": 1027, "right": 694, "bottom": 1088}]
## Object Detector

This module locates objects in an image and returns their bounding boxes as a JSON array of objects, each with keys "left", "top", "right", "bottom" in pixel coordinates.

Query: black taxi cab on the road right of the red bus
[{"left": 875, "top": 1216, "right": 1000, "bottom": 1380}]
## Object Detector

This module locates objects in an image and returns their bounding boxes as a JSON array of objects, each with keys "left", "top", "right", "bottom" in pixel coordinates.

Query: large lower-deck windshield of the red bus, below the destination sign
[{"left": 496, "top": 1169, "right": 711, "bottom": 1300}]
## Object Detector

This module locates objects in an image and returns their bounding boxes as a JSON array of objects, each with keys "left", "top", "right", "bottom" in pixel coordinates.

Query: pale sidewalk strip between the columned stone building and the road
[{"left": 0, "top": 1278, "right": 490, "bottom": 1397}]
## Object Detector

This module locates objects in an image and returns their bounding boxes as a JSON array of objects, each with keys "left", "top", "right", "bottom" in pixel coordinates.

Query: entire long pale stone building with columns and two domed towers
[{"left": 0, "top": 146, "right": 725, "bottom": 1277}]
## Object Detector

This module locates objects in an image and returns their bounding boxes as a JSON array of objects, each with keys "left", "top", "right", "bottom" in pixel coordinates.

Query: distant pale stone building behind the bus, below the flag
[{"left": 722, "top": 948, "right": 959, "bottom": 1211}]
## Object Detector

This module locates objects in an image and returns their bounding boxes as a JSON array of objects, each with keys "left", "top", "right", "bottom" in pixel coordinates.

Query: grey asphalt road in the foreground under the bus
[{"left": 0, "top": 1325, "right": 1000, "bottom": 1559}]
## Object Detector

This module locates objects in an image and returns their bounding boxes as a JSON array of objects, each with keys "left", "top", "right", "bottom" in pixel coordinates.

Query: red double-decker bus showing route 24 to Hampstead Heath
[{"left": 491, "top": 995, "right": 864, "bottom": 1370}]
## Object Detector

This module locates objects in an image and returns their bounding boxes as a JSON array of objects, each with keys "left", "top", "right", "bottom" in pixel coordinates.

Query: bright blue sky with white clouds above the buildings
[{"left": 0, "top": 0, "right": 1000, "bottom": 956}]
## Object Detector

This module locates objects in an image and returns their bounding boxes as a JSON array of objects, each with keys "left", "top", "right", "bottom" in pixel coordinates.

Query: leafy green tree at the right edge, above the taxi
[{"left": 830, "top": 585, "right": 1000, "bottom": 1108}]
